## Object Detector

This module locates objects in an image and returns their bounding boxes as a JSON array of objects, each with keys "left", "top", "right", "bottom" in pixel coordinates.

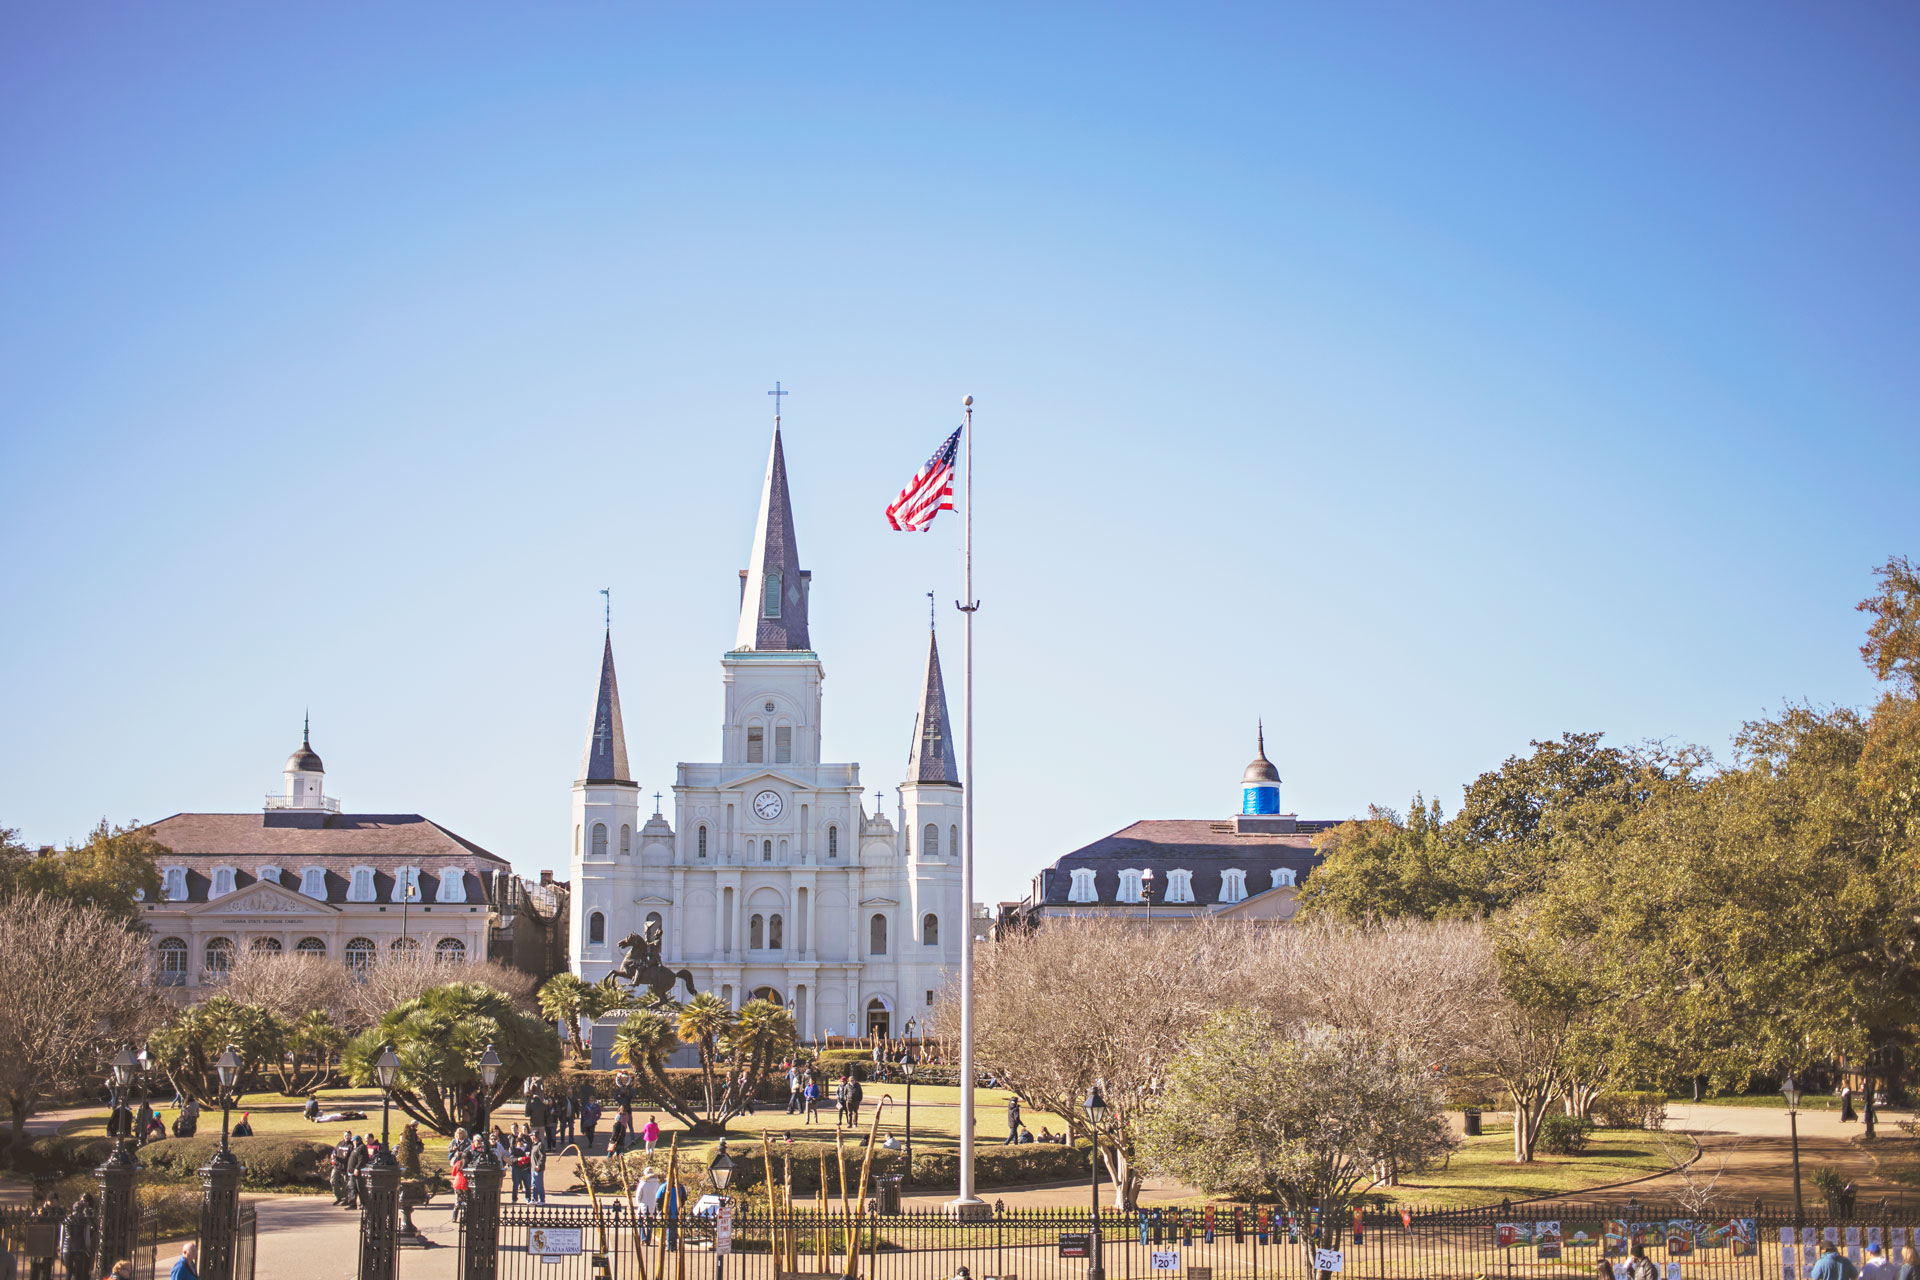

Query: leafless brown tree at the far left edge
[{"left": 0, "top": 894, "right": 163, "bottom": 1142}]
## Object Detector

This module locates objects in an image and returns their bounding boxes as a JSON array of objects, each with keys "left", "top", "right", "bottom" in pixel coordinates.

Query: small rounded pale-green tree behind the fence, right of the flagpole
[{"left": 1142, "top": 1009, "right": 1457, "bottom": 1259}]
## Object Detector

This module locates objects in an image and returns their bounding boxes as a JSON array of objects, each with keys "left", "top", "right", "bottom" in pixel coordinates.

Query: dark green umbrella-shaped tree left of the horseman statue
[{"left": 346, "top": 983, "right": 561, "bottom": 1134}]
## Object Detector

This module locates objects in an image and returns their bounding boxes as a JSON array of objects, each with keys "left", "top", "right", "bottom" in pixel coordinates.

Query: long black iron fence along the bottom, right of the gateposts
[{"left": 468, "top": 1201, "right": 1920, "bottom": 1280}]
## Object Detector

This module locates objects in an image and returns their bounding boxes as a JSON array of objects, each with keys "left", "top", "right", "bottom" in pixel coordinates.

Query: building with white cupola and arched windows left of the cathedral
[{"left": 140, "top": 729, "right": 566, "bottom": 1000}]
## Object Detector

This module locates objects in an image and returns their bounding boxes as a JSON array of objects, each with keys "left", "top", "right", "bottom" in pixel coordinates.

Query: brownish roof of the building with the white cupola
[{"left": 141, "top": 810, "right": 509, "bottom": 906}]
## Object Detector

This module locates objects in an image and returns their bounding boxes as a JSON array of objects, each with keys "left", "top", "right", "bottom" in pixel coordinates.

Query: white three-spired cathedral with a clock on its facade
[{"left": 570, "top": 418, "right": 968, "bottom": 1065}]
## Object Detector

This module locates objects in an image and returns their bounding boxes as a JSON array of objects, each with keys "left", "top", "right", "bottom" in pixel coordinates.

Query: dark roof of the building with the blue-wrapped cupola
[{"left": 1033, "top": 818, "right": 1338, "bottom": 906}]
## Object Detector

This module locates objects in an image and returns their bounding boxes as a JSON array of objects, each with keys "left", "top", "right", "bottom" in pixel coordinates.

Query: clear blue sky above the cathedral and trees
[{"left": 0, "top": 4, "right": 1920, "bottom": 898}]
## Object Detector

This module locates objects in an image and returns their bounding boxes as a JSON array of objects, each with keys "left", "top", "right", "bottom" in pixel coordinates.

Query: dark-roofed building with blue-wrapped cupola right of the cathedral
[{"left": 995, "top": 723, "right": 1338, "bottom": 931}]
